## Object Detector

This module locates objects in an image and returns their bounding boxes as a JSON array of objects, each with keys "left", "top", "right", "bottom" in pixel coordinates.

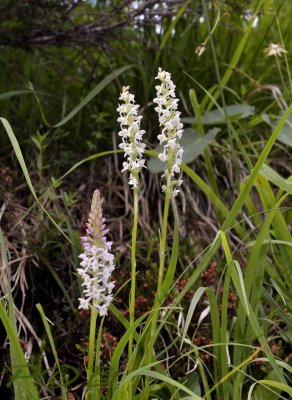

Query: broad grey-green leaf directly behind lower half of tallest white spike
[{"left": 148, "top": 128, "right": 220, "bottom": 173}]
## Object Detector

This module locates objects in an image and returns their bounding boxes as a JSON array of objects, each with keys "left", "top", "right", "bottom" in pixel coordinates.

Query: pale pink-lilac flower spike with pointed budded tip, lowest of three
[{"left": 77, "top": 190, "right": 115, "bottom": 316}]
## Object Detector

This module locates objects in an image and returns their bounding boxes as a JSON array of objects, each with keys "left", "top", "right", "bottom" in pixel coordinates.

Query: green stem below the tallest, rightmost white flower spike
[{"left": 143, "top": 180, "right": 171, "bottom": 400}]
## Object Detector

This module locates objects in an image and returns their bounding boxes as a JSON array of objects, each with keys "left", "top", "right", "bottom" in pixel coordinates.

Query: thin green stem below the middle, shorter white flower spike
[{"left": 128, "top": 188, "right": 139, "bottom": 400}]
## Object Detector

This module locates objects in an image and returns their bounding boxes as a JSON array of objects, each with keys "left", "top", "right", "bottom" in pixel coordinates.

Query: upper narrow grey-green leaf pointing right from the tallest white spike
[{"left": 182, "top": 104, "right": 255, "bottom": 125}]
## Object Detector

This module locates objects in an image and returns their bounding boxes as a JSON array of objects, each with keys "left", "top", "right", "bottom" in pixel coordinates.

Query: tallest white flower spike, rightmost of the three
[{"left": 153, "top": 68, "right": 183, "bottom": 197}]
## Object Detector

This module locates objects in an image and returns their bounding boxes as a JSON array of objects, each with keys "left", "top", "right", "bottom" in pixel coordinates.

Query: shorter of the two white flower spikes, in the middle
[{"left": 117, "top": 86, "right": 146, "bottom": 189}]
